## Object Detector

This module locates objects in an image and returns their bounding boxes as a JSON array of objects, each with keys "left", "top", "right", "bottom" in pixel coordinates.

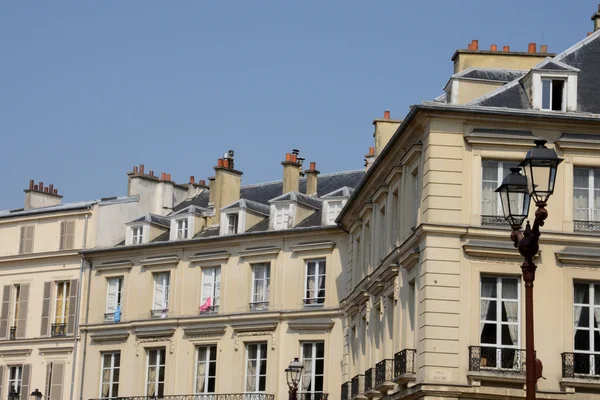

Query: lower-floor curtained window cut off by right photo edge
[{"left": 573, "top": 282, "right": 600, "bottom": 375}]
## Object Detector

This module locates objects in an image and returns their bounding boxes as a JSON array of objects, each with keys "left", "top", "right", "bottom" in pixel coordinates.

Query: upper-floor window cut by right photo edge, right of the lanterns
[{"left": 573, "top": 168, "right": 600, "bottom": 221}]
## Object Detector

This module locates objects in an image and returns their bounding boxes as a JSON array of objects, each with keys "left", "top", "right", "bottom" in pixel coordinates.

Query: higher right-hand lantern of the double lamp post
[{"left": 519, "top": 140, "right": 563, "bottom": 202}]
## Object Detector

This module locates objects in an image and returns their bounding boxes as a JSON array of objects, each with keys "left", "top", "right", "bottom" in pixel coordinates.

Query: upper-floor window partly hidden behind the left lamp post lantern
[{"left": 481, "top": 160, "right": 518, "bottom": 225}]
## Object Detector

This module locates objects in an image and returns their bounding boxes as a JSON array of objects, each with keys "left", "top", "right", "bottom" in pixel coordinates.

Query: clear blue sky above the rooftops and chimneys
[{"left": 0, "top": 0, "right": 598, "bottom": 209}]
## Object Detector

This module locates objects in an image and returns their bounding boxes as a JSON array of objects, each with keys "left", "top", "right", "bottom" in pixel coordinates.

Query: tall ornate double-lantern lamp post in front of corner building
[{"left": 496, "top": 140, "right": 563, "bottom": 400}]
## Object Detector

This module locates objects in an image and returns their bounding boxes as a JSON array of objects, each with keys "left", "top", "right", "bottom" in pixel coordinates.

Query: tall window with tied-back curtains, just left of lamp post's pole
[{"left": 479, "top": 277, "right": 524, "bottom": 370}]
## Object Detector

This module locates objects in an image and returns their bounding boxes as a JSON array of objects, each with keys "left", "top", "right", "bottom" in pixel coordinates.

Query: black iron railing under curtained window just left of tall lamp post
[{"left": 469, "top": 346, "right": 525, "bottom": 373}]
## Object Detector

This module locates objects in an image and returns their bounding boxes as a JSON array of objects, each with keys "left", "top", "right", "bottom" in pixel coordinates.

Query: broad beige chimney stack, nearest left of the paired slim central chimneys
[{"left": 209, "top": 150, "right": 242, "bottom": 223}]
